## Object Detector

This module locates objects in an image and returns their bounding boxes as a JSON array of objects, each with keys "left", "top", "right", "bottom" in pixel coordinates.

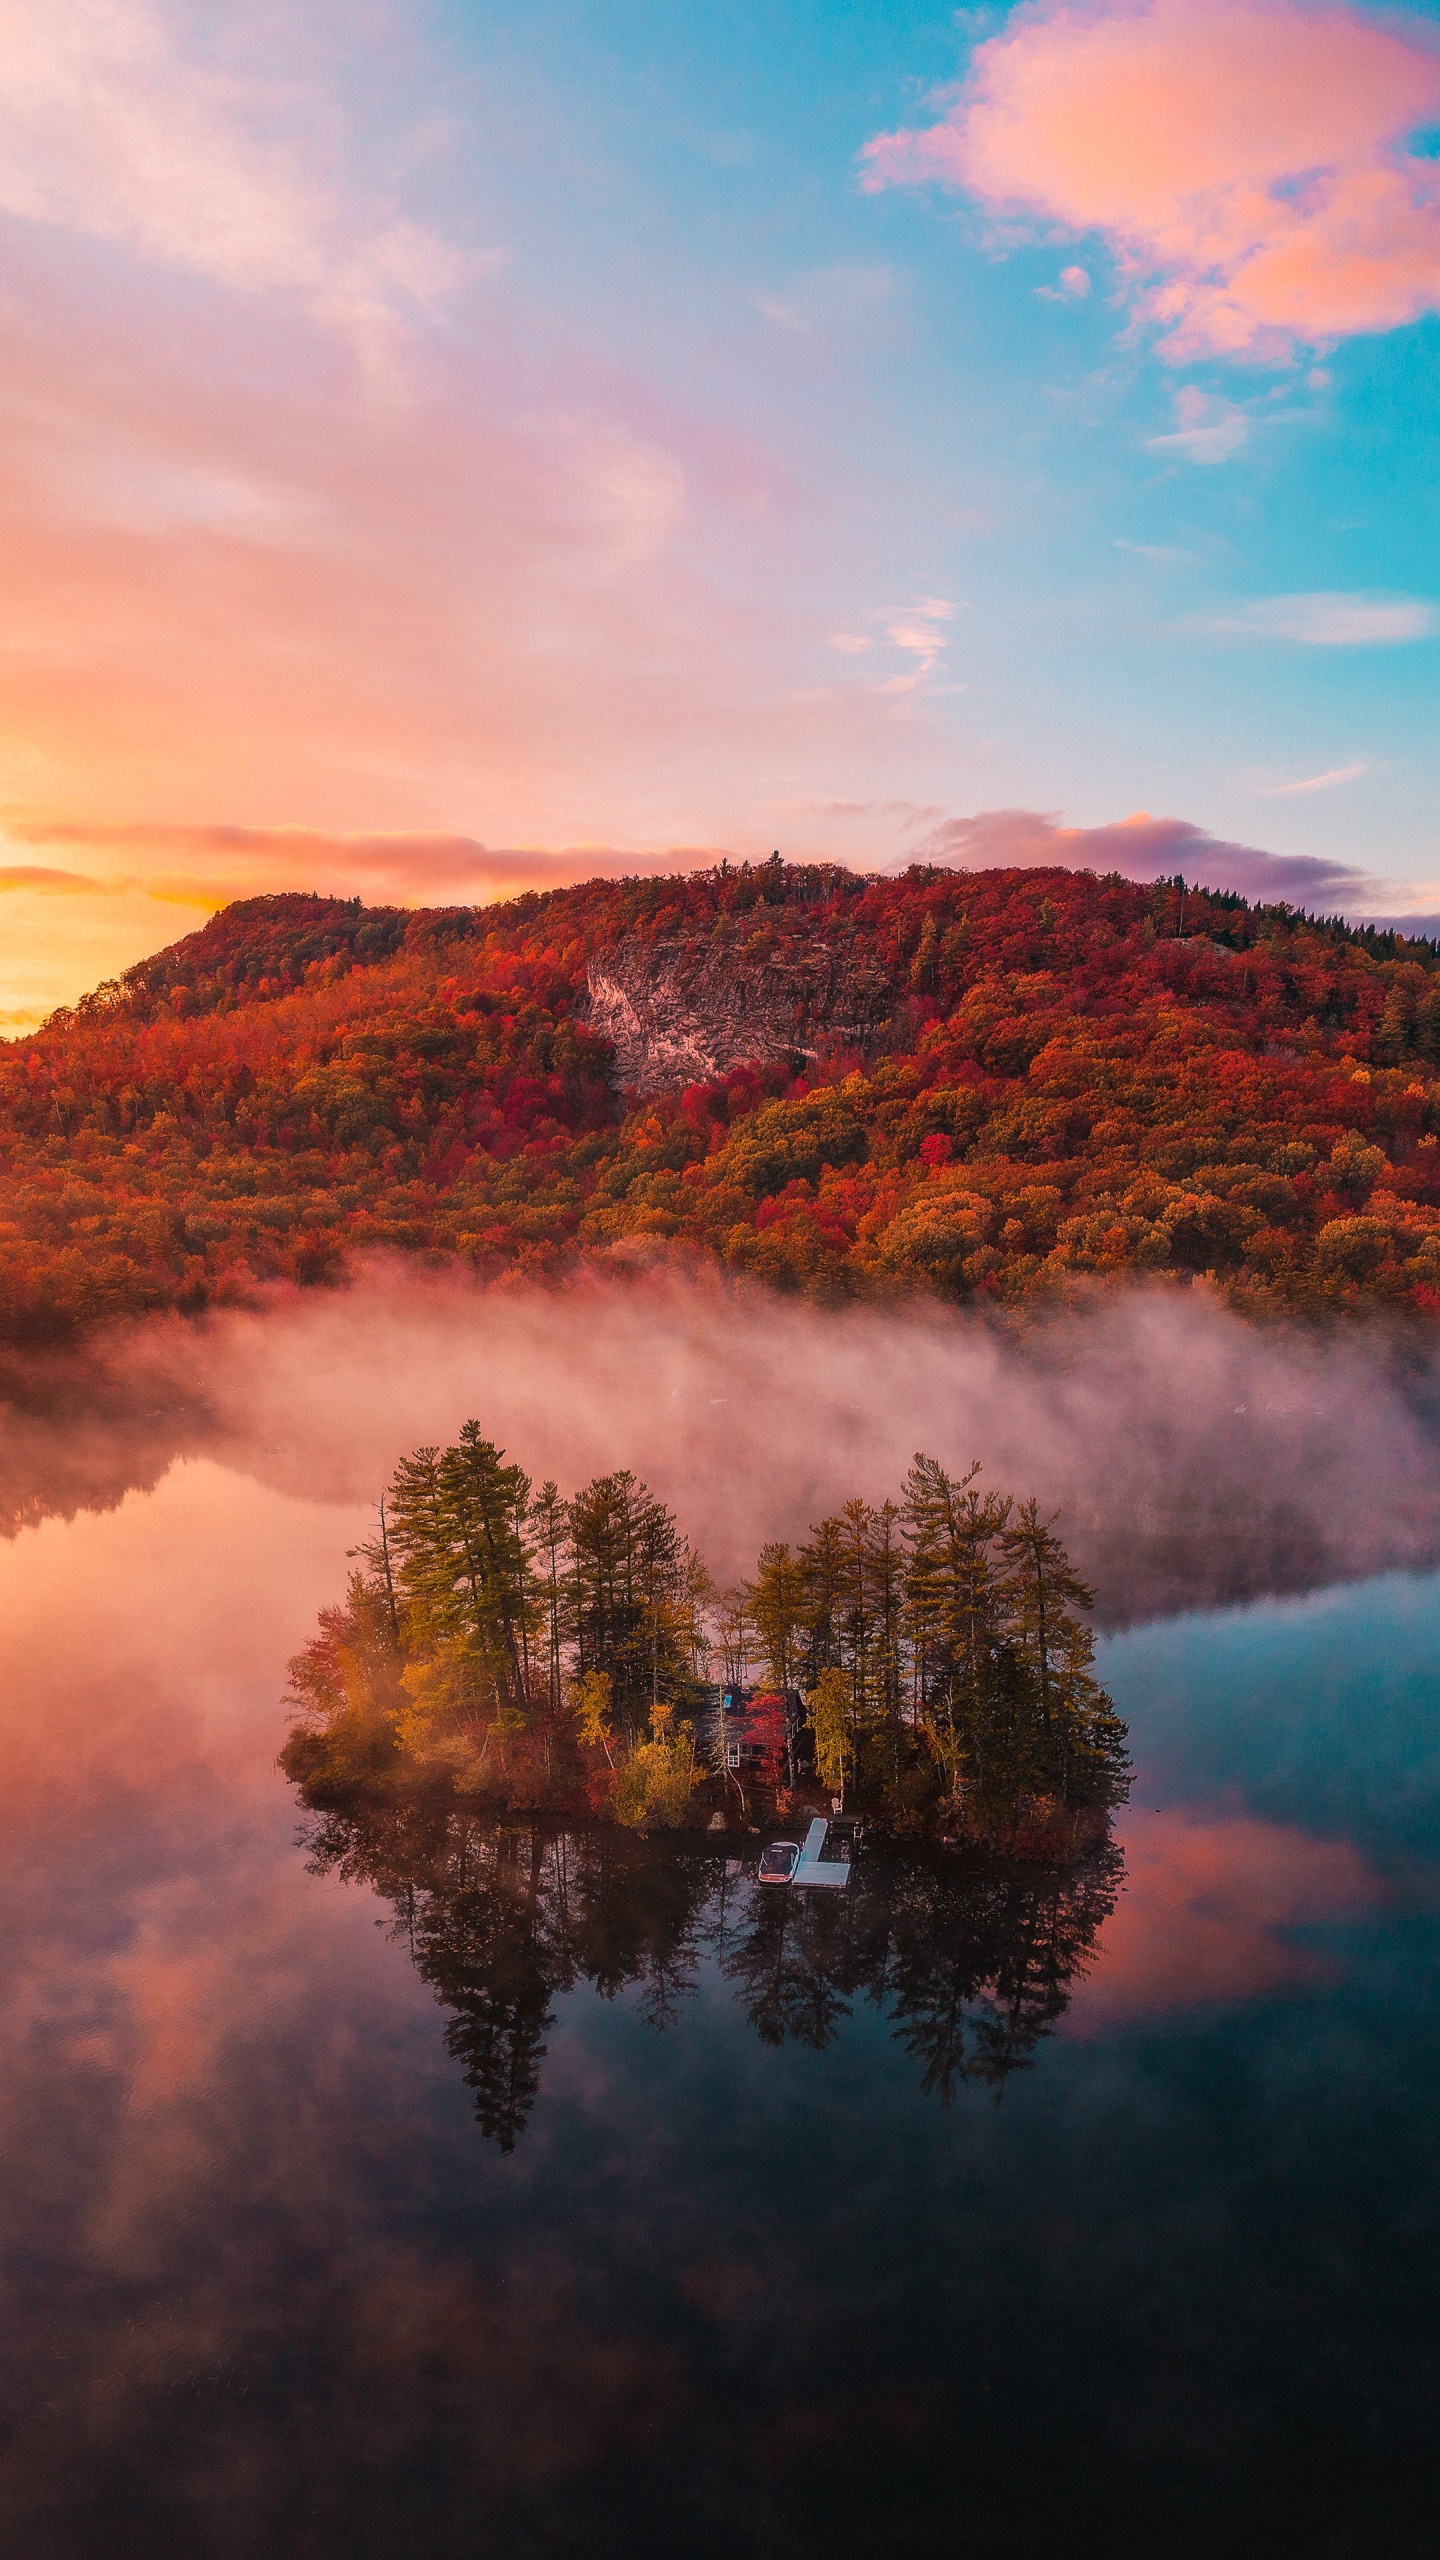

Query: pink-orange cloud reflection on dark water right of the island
[{"left": 1071, "top": 1815, "right": 1381, "bottom": 2033}]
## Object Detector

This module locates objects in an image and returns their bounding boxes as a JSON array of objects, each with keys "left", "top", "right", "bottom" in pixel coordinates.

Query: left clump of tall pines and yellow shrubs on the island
[{"left": 284, "top": 1421, "right": 710, "bottom": 1825}]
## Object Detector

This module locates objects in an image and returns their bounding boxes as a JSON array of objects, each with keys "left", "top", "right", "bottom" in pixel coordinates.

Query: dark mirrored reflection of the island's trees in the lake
[{"left": 305, "top": 1802, "right": 1125, "bottom": 2150}]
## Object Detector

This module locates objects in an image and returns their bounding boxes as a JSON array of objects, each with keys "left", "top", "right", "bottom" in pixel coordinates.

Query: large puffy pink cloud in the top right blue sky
[{"left": 863, "top": 0, "right": 1440, "bottom": 364}]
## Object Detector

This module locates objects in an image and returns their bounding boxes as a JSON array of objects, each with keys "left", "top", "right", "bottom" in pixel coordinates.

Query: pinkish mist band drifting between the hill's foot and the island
[{"left": 0, "top": 1267, "right": 1440, "bottom": 1623}]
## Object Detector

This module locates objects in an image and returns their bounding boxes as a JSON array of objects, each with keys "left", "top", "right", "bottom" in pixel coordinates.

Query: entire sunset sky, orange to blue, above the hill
[{"left": 0, "top": 0, "right": 1440, "bottom": 1034}]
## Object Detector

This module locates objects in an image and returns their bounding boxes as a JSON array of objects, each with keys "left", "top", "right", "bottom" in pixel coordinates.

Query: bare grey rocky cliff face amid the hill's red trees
[{"left": 576, "top": 929, "right": 894, "bottom": 1093}]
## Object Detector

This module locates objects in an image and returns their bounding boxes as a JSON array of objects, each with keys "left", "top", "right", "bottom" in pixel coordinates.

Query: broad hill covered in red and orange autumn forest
[{"left": 0, "top": 860, "right": 1440, "bottom": 1344}]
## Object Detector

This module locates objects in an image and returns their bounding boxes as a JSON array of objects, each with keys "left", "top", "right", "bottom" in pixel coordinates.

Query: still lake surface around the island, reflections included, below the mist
[{"left": 0, "top": 1464, "right": 1440, "bottom": 2560}]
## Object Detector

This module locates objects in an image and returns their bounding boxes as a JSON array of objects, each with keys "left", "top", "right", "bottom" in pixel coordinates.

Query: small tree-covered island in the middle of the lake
[{"left": 282, "top": 1421, "right": 1127, "bottom": 1864}]
